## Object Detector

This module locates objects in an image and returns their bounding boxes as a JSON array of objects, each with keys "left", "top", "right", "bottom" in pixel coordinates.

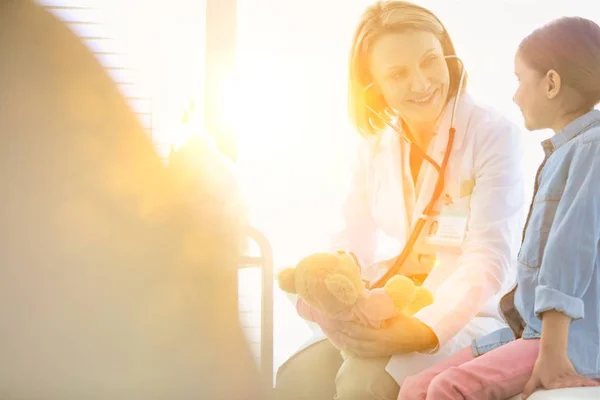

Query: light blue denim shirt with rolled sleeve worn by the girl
[{"left": 473, "top": 110, "right": 600, "bottom": 378}]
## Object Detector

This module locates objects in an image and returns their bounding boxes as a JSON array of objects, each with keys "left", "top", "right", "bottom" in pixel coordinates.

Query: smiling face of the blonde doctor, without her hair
[{"left": 369, "top": 30, "right": 450, "bottom": 129}]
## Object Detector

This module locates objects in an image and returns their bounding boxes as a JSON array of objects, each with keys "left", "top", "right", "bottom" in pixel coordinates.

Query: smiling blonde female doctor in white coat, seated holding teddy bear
[{"left": 276, "top": 1, "right": 524, "bottom": 400}]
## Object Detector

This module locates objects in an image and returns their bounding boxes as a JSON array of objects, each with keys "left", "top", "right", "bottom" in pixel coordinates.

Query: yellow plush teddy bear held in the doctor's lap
[{"left": 278, "top": 252, "right": 433, "bottom": 348}]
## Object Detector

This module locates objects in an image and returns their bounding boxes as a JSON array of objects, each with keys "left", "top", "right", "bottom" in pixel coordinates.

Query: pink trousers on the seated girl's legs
[{"left": 398, "top": 339, "right": 540, "bottom": 400}]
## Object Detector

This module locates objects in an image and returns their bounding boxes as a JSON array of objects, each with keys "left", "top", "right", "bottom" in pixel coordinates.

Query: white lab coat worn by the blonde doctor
[{"left": 333, "top": 94, "right": 524, "bottom": 383}]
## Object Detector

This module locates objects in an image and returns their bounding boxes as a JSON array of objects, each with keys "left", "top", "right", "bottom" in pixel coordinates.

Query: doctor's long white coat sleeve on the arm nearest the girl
[{"left": 414, "top": 118, "right": 524, "bottom": 348}]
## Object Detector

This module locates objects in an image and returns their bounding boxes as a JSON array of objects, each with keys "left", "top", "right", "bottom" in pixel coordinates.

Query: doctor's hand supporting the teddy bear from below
[{"left": 339, "top": 314, "right": 438, "bottom": 358}]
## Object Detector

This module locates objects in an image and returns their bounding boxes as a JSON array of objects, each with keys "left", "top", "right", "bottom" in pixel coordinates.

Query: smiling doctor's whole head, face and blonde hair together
[{"left": 348, "top": 1, "right": 466, "bottom": 136}]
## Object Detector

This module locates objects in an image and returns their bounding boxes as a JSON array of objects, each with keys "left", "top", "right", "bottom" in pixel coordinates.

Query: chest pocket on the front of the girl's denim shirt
[{"left": 518, "top": 196, "right": 559, "bottom": 268}]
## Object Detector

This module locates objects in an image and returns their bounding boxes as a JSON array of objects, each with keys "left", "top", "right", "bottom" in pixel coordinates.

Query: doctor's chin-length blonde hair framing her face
[{"left": 348, "top": 1, "right": 466, "bottom": 136}]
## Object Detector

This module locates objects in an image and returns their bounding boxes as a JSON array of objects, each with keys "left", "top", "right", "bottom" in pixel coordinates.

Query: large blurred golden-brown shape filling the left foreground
[{"left": 0, "top": 0, "right": 264, "bottom": 400}]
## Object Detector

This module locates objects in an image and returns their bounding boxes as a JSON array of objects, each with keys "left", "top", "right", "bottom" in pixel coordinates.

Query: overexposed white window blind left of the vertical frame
[{"left": 37, "top": 0, "right": 206, "bottom": 161}]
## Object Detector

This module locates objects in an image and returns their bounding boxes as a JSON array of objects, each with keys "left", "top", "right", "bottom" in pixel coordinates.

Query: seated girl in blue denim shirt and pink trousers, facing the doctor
[{"left": 399, "top": 17, "right": 600, "bottom": 400}]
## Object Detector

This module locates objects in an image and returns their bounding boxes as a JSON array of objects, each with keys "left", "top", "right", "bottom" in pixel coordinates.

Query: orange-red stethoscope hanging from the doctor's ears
[{"left": 365, "top": 55, "right": 465, "bottom": 289}]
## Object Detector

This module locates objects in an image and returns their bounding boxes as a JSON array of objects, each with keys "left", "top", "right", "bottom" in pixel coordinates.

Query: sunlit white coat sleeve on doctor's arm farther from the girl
[{"left": 330, "top": 140, "right": 376, "bottom": 267}]
